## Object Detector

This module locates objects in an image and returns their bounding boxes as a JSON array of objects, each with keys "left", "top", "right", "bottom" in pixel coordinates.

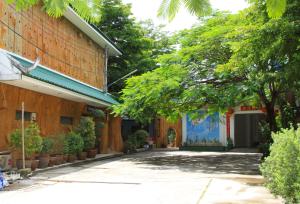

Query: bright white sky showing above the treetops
[{"left": 123, "top": 0, "right": 248, "bottom": 32}]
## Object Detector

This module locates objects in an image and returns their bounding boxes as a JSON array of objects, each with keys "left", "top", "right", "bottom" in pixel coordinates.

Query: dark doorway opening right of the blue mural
[{"left": 234, "top": 113, "right": 265, "bottom": 147}]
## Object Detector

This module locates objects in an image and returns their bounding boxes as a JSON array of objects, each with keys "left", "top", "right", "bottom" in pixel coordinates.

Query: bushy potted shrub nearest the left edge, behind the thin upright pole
[{"left": 10, "top": 122, "right": 43, "bottom": 170}]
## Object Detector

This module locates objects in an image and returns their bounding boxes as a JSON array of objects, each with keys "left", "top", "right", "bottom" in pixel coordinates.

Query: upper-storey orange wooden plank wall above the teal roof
[{"left": 0, "top": 0, "right": 104, "bottom": 89}]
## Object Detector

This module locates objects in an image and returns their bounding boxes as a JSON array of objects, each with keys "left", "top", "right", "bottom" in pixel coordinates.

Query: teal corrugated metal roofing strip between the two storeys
[{"left": 10, "top": 53, "right": 118, "bottom": 104}]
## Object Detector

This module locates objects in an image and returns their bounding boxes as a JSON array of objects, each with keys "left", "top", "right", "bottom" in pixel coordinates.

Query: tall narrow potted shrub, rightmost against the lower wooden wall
[{"left": 76, "top": 117, "right": 97, "bottom": 159}]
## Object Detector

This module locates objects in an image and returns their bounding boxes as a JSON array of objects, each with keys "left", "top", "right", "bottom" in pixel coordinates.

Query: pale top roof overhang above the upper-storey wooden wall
[{"left": 64, "top": 7, "right": 122, "bottom": 56}]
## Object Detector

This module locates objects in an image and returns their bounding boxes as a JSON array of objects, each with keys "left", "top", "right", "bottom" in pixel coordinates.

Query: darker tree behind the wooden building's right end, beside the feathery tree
[{"left": 97, "top": 0, "right": 175, "bottom": 95}]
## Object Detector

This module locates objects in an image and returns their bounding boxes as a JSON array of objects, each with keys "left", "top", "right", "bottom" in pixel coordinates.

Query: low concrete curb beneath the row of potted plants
[{"left": 32, "top": 153, "right": 124, "bottom": 176}]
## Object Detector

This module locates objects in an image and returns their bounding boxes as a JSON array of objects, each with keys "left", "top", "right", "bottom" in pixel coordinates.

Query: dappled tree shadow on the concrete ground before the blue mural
[{"left": 127, "top": 152, "right": 261, "bottom": 175}]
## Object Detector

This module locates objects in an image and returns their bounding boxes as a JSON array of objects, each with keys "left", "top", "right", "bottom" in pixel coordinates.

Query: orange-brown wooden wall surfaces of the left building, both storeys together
[{"left": 0, "top": 0, "right": 123, "bottom": 155}]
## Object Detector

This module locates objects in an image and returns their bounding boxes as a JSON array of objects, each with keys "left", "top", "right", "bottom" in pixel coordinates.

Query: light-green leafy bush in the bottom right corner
[{"left": 260, "top": 127, "right": 300, "bottom": 203}]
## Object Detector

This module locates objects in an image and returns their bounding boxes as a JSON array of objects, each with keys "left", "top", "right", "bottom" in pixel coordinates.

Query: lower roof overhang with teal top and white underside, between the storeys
[{"left": 0, "top": 49, "right": 118, "bottom": 107}]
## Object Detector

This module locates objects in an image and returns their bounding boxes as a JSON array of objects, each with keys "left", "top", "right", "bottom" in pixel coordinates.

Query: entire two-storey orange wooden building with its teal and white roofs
[{"left": 0, "top": 0, "right": 122, "bottom": 158}]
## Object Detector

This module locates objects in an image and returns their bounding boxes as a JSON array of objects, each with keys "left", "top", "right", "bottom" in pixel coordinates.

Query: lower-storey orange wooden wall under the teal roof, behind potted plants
[{"left": 0, "top": 83, "right": 85, "bottom": 150}]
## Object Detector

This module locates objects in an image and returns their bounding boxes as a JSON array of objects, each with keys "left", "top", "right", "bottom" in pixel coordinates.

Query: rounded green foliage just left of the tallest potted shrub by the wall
[{"left": 64, "top": 131, "right": 84, "bottom": 155}]
